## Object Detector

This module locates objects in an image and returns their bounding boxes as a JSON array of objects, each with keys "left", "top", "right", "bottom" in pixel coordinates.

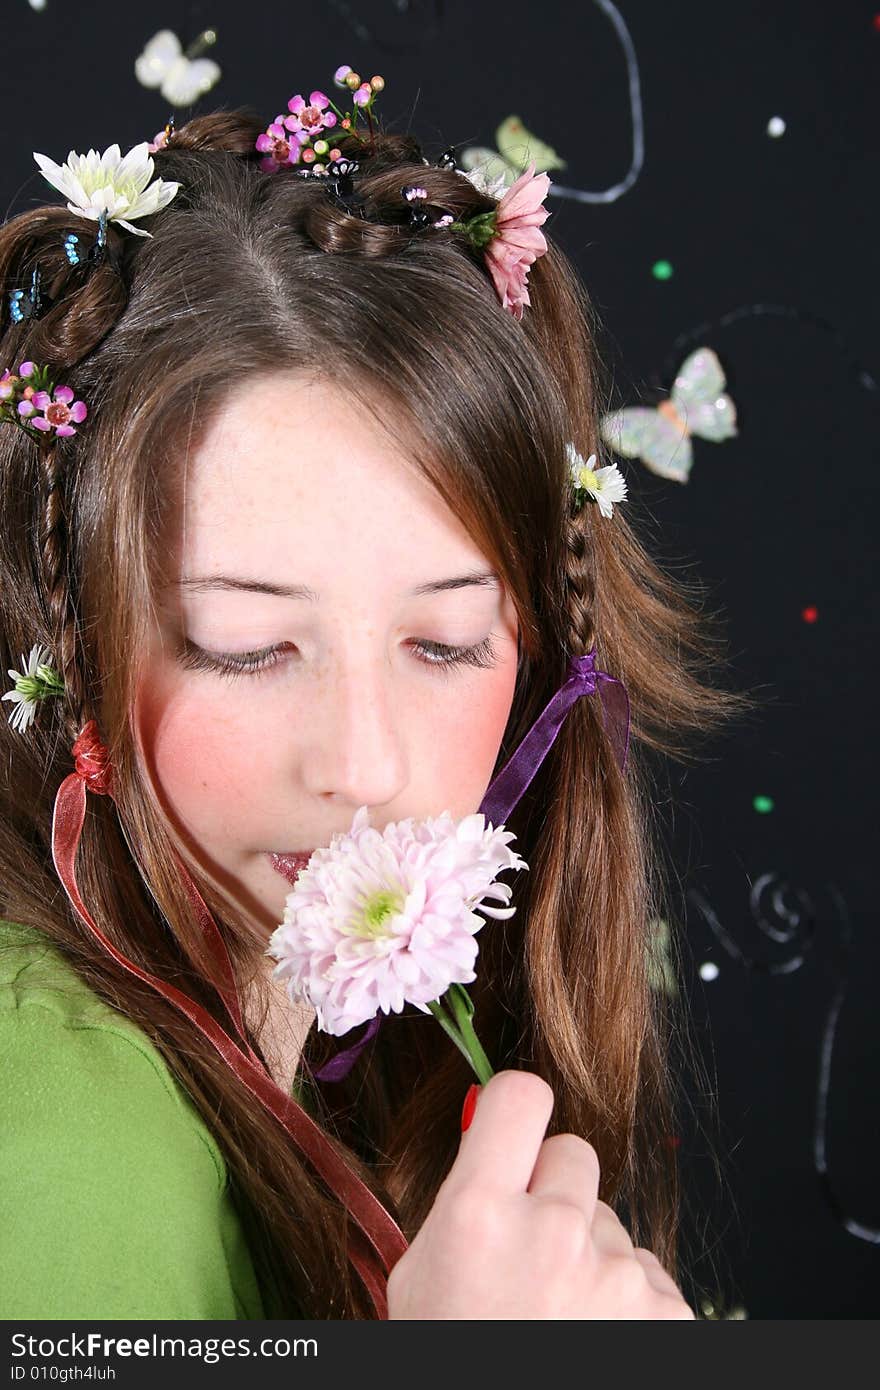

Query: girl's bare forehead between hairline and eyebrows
[{"left": 175, "top": 374, "right": 484, "bottom": 587}]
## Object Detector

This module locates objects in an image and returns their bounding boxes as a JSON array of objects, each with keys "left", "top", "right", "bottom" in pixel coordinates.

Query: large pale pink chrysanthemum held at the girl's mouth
[{"left": 266, "top": 806, "right": 528, "bottom": 1036}]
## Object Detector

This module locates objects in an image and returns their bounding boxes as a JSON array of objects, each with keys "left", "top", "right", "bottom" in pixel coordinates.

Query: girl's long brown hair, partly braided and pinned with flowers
[{"left": 0, "top": 110, "right": 749, "bottom": 1318}]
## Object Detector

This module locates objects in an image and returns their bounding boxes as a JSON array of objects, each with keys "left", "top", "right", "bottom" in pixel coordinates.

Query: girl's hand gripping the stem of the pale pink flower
[{"left": 388, "top": 1072, "right": 694, "bottom": 1321}]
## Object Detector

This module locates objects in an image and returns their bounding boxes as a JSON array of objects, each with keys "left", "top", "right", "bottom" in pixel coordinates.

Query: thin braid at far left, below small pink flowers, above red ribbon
[{"left": 39, "top": 441, "right": 86, "bottom": 737}]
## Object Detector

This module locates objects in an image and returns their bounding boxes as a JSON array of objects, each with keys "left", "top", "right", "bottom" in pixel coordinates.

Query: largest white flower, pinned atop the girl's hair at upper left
[{"left": 33, "top": 140, "right": 181, "bottom": 236}]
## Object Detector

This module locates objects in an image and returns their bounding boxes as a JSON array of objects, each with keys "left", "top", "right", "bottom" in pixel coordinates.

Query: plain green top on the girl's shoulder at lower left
[{"left": 0, "top": 920, "right": 267, "bottom": 1321}]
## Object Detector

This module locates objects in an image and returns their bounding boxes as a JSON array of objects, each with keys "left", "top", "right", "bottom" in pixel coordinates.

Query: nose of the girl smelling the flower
[{"left": 303, "top": 636, "right": 409, "bottom": 809}]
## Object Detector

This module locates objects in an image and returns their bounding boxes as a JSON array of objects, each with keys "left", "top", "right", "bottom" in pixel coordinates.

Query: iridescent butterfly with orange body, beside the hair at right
[{"left": 599, "top": 348, "right": 737, "bottom": 482}]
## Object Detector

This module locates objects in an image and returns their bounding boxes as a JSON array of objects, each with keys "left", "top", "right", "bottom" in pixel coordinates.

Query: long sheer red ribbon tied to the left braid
[{"left": 51, "top": 720, "right": 406, "bottom": 1319}]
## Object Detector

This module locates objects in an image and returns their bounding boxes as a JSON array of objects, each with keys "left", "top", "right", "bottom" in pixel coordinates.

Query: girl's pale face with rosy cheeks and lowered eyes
[{"left": 135, "top": 375, "right": 517, "bottom": 934}]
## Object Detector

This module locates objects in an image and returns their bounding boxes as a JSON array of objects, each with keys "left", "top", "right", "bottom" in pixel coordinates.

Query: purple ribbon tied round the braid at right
[{"left": 314, "top": 648, "right": 630, "bottom": 1081}]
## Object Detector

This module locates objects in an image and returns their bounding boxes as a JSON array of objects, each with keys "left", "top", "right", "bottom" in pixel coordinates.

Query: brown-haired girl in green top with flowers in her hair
[{"left": 0, "top": 95, "right": 747, "bottom": 1319}]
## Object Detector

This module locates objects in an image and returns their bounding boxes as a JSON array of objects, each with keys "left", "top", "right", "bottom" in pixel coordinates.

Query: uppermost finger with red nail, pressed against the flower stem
[{"left": 445, "top": 1072, "right": 553, "bottom": 1194}]
